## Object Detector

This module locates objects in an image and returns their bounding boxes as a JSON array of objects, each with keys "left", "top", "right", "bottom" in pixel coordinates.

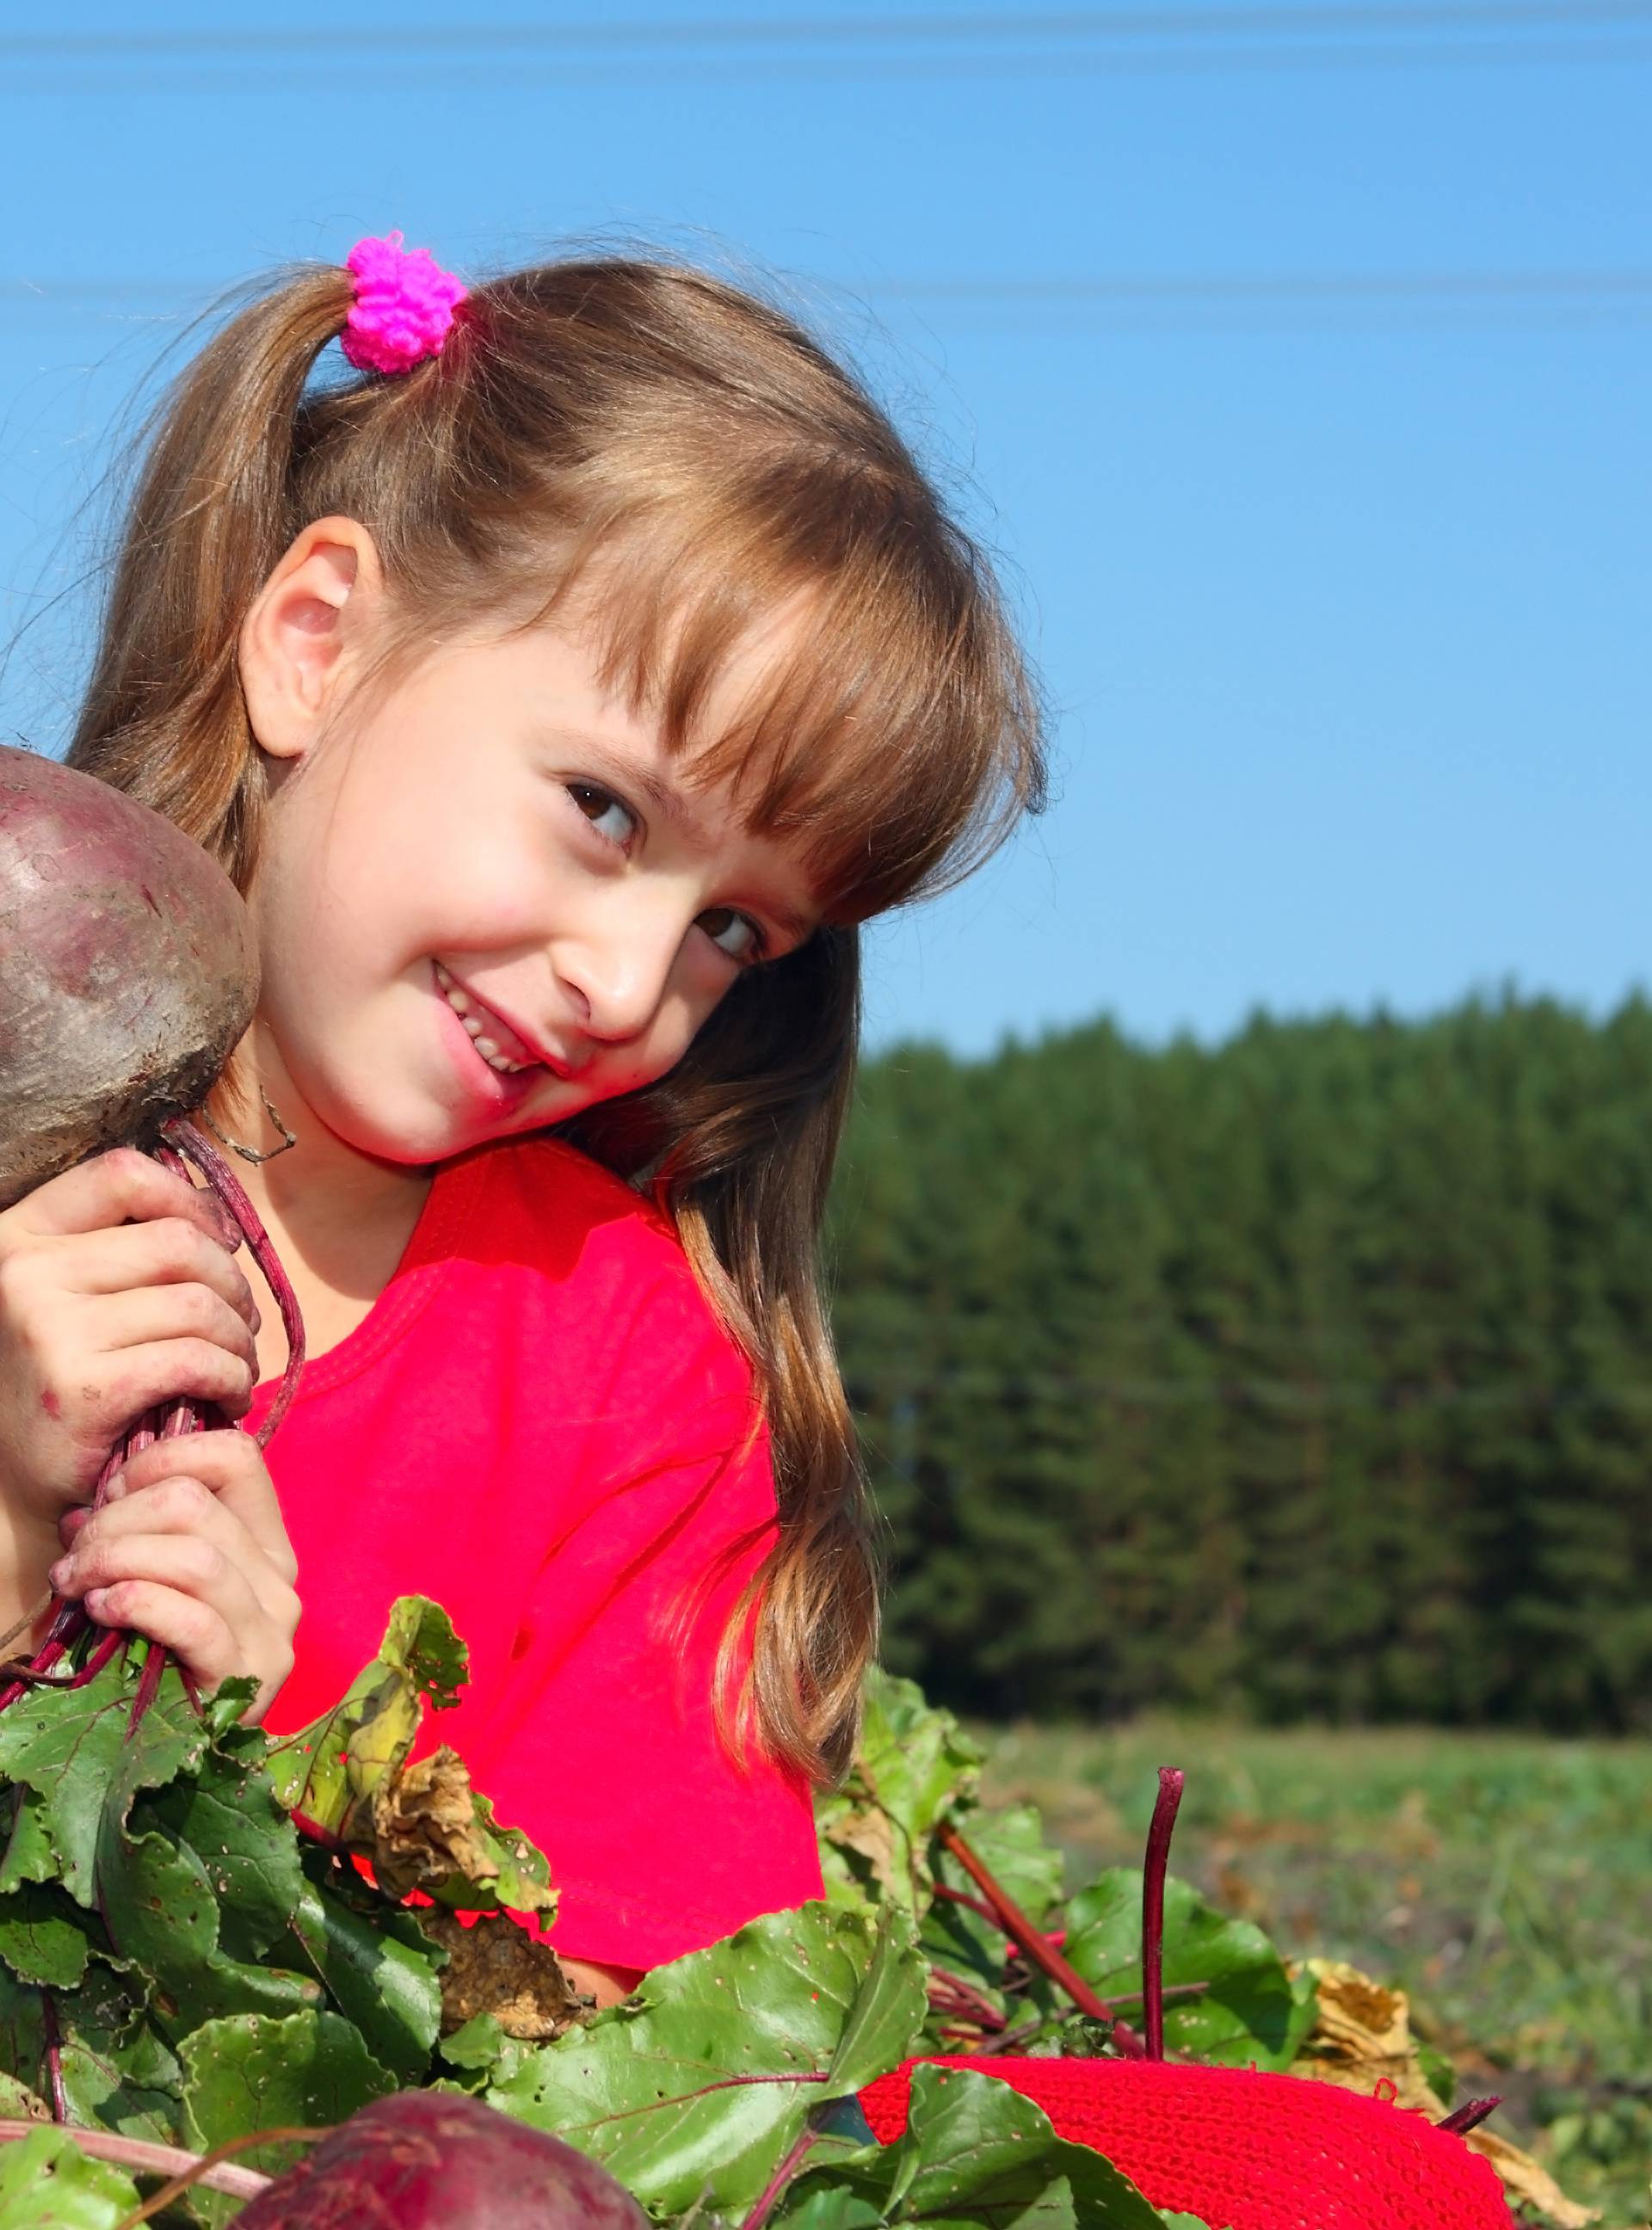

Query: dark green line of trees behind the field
[{"left": 829, "top": 997, "right": 1652, "bottom": 1728}]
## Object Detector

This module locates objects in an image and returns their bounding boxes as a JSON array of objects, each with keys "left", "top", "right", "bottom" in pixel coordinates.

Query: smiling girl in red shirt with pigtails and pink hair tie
[{"left": 0, "top": 234, "right": 1041, "bottom": 2003}]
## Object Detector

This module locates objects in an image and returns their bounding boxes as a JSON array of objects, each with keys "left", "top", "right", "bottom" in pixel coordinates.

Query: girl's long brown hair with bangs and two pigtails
[{"left": 69, "top": 256, "right": 1044, "bottom": 1779}]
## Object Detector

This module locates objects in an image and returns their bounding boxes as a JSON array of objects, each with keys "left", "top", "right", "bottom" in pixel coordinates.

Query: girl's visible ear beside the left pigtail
[{"left": 238, "top": 517, "right": 384, "bottom": 761}]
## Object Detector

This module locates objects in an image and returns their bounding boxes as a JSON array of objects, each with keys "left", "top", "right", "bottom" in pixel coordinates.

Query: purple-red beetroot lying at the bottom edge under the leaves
[{"left": 237, "top": 2091, "right": 649, "bottom": 2230}]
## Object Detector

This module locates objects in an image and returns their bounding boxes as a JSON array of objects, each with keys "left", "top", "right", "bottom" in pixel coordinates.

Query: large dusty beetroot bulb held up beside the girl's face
[{"left": 0, "top": 745, "right": 259, "bottom": 1206}]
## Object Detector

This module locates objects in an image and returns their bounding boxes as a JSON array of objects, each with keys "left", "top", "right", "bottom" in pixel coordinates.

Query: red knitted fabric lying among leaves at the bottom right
[{"left": 860, "top": 2054, "right": 1513, "bottom": 2230}]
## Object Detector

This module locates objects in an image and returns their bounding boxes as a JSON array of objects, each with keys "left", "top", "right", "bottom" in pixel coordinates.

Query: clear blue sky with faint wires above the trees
[{"left": 0, "top": 0, "right": 1652, "bottom": 1052}]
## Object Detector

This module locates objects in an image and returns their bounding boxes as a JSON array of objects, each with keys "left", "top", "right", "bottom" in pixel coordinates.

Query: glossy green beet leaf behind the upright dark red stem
[{"left": 1066, "top": 1867, "right": 1313, "bottom": 2069}]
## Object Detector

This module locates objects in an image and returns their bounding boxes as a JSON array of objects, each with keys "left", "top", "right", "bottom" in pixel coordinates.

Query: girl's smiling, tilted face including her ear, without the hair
[{"left": 243, "top": 520, "right": 816, "bottom": 1164}]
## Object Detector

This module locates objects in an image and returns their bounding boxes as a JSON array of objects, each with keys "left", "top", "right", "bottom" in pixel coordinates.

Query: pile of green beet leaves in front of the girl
[{"left": 0, "top": 1597, "right": 1569, "bottom": 2230}]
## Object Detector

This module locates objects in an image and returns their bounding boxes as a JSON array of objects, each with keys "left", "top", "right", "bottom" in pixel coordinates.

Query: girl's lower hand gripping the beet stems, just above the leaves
[{"left": 52, "top": 1432, "right": 299, "bottom": 1724}]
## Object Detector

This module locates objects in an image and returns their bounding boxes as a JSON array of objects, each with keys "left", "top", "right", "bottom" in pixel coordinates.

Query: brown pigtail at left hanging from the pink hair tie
[{"left": 67, "top": 268, "right": 350, "bottom": 890}]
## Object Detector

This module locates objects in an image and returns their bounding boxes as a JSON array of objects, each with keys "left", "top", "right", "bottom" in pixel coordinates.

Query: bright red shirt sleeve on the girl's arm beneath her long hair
[{"left": 443, "top": 1265, "right": 823, "bottom": 1967}]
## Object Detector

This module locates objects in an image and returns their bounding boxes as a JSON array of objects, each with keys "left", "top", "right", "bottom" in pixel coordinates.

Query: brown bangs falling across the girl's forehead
[{"left": 558, "top": 495, "right": 1044, "bottom": 923}]
